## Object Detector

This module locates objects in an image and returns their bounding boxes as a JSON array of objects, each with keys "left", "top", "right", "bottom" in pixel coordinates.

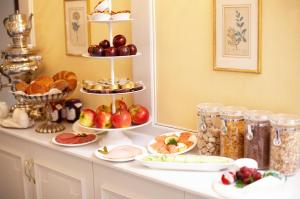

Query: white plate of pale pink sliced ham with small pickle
[{"left": 94, "top": 144, "right": 147, "bottom": 162}]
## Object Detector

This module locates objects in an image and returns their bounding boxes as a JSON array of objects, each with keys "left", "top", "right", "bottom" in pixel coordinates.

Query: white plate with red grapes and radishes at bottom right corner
[{"left": 213, "top": 166, "right": 286, "bottom": 199}]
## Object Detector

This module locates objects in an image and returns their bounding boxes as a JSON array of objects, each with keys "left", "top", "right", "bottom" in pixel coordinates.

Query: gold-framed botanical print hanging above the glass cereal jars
[{"left": 214, "top": 0, "right": 261, "bottom": 73}]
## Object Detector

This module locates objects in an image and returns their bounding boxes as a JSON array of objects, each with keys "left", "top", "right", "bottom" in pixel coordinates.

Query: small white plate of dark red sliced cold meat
[{"left": 52, "top": 132, "right": 97, "bottom": 147}]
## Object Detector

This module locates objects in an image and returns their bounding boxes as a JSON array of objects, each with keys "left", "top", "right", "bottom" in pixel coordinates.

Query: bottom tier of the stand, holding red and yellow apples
[{"left": 75, "top": 100, "right": 151, "bottom": 132}]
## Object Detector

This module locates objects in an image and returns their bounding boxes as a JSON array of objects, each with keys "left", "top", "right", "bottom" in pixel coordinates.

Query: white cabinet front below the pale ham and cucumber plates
[{"left": 94, "top": 164, "right": 184, "bottom": 199}]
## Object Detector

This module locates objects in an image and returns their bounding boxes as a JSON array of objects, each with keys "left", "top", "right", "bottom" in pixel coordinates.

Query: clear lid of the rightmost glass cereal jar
[{"left": 270, "top": 114, "right": 300, "bottom": 127}]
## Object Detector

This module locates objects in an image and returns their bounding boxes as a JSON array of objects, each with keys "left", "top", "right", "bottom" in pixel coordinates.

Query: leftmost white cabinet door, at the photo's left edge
[{"left": 0, "top": 150, "right": 25, "bottom": 199}]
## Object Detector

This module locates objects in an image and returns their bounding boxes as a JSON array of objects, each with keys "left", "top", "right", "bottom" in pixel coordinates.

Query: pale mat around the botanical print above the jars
[{"left": 215, "top": 0, "right": 259, "bottom": 71}]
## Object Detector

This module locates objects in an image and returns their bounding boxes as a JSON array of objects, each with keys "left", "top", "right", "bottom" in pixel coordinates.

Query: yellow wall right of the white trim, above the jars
[{"left": 156, "top": 0, "right": 300, "bottom": 129}]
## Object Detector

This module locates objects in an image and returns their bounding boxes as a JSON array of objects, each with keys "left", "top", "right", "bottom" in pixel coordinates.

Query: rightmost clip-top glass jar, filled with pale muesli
[{"left": 270, "top": 114, "right": 300, "bottom": 175}]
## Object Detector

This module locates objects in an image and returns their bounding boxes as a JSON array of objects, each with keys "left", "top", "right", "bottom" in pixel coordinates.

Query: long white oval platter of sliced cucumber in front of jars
[{"left": 136, "top": 154, "right": 234, "bottom": 171}]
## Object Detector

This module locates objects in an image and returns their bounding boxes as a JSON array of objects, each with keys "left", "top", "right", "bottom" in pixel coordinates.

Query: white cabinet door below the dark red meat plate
[{"left": 32, "top": 145, "right": 94, "bottom": 199}]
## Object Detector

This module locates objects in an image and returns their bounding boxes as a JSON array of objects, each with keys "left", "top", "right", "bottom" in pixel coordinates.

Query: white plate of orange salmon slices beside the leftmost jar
[{"left": 148, "top": 132, "right": 197, "bottom": 155}]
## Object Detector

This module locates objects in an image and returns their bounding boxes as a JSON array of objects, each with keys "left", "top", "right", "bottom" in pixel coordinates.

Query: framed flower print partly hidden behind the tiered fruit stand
[{"left": 64, "top": 0, "right": 90, "bottom": 56}]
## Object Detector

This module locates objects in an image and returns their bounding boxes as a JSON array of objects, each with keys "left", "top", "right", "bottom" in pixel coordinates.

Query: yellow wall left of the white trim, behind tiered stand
[{"left": 34, "top": 0, "right": 131, "bottom": 107}]
